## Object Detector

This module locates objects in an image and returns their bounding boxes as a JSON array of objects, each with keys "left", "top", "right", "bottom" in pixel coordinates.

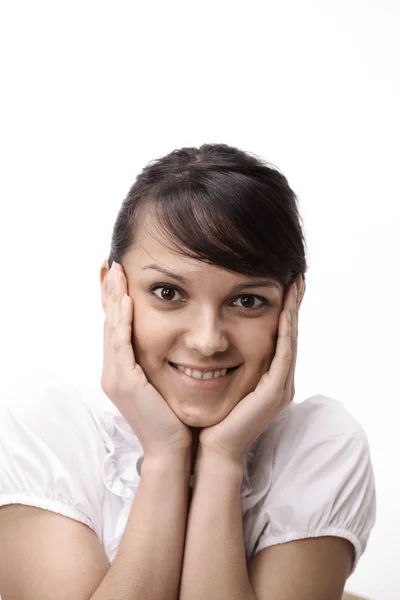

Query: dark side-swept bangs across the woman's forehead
[{"left": 148, "top": 170, "right": 293, "bottom": 285}]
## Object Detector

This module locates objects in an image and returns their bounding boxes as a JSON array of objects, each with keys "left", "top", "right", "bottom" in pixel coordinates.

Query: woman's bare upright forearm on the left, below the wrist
[{"left": 91, "top": 450, "right": 190, "bottom": 600}]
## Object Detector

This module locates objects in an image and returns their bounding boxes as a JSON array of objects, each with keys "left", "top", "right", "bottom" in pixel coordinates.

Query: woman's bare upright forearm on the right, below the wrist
[{"left": 179, "top": 447, "right": 256, "bottom": 600}]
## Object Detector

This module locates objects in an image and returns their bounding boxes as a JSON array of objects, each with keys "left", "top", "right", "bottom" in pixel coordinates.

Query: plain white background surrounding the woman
[{"left": 0, "top": 0, "right": 400, "bottom": 600}]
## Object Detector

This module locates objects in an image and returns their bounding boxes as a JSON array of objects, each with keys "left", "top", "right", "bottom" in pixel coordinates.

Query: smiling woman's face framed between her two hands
[{"left": 101, "top": 222, "right": 284, "bottom": 427}]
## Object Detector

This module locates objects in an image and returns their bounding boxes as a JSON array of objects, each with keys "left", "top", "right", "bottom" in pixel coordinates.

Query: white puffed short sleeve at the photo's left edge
[{"left": 0, "top": 378, "right": 104, "bottom": 540}]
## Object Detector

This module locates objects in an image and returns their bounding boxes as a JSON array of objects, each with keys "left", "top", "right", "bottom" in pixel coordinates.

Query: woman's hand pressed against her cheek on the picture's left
[{"left": 101, "top": 262, "right": 192, "bottom": 458}]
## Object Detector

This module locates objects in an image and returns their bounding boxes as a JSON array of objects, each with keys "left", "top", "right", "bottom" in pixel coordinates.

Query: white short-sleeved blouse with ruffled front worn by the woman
[{"left": 0, "top": 375, "right": 376, "bottom": 571}]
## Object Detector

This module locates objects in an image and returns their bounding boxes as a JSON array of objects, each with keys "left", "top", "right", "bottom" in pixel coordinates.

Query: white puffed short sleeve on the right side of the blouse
[{"left": 254, "top": 398, "right": 376, "bottom": 573}]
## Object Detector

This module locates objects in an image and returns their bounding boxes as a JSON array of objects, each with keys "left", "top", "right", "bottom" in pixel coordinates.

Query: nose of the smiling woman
[{"left": 186, "top": 311, "right": 229, "bottom": 356}]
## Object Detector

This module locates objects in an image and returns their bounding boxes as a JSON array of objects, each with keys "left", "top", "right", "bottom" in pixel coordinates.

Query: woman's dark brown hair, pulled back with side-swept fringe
[{"left": 108, "top": 144, "right": 307, "bottom": 287}]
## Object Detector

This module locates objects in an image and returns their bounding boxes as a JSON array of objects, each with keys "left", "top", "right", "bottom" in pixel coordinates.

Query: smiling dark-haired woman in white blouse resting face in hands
[{"left": 0, "top": 144, "right": 375, "bottom": 600}]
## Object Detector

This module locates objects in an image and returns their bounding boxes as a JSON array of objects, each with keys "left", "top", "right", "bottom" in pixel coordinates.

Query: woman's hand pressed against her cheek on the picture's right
[{"left": 199, "top": 275, "right": 305, "bottom": 463}]
